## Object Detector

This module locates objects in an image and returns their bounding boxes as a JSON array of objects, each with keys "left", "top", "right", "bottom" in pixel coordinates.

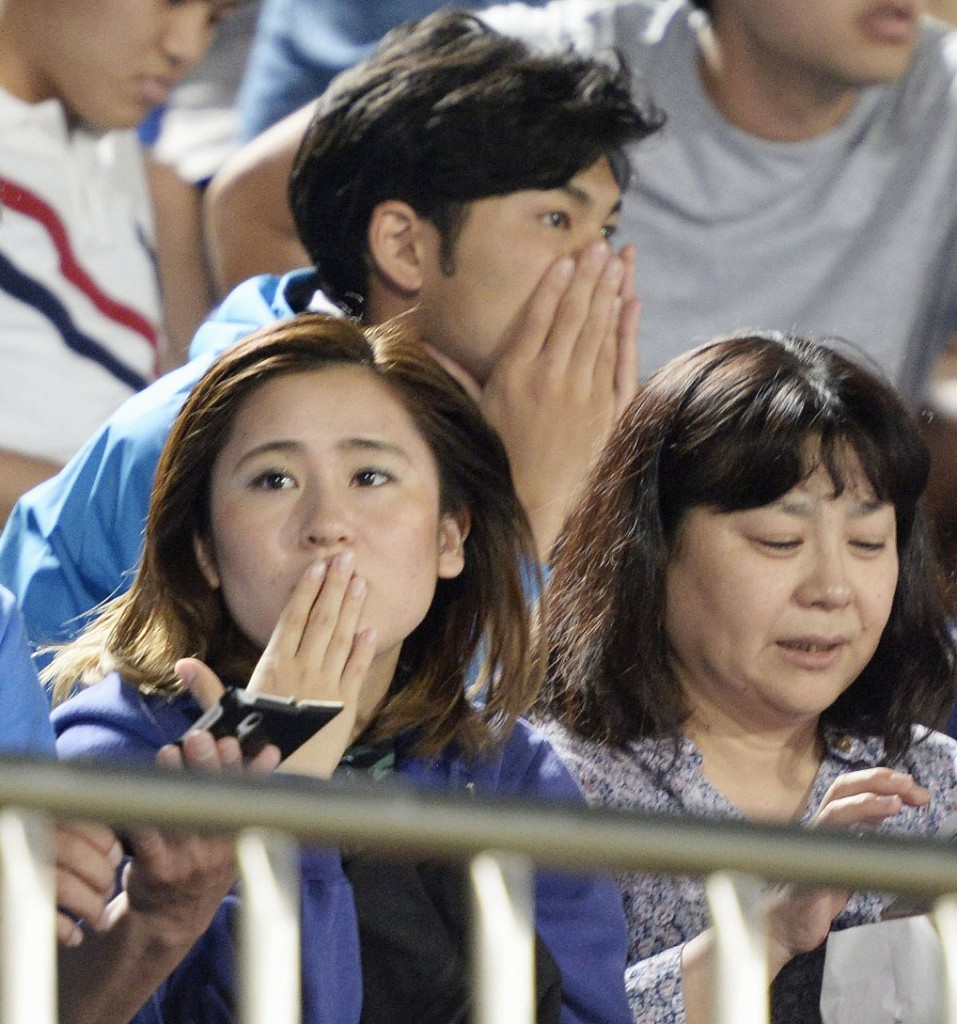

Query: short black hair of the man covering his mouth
[{"left": 289, "top": 8, "right": 662, "bottom": 311}]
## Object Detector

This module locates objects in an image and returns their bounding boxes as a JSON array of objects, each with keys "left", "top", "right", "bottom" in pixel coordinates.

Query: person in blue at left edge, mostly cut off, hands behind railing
[{"left": 0, "top": 587, "right": 252, "bottom": 1024}]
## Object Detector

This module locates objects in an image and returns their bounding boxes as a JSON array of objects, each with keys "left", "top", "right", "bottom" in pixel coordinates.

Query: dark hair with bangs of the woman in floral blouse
[{"left": 545, "top": 333, "right": 957, "bottom": 758}]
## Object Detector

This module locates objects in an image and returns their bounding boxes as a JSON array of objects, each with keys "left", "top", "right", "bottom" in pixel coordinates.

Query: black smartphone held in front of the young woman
[{"left": 179, "top": 688, "right": 342, "bottom": 761}]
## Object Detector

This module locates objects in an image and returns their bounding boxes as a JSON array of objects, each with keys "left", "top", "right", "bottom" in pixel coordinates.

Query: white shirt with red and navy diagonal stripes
[{"left": 0, "top": 90, "right": 162, "bottom": 462}]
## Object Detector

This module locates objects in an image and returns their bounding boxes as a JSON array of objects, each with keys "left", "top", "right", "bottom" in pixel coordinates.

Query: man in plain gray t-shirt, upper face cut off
[{"left": 483, "top": 0, "right": 957, "bottom": 552}]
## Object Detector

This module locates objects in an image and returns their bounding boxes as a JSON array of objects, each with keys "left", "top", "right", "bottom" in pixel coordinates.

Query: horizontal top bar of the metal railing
[{"left": 0, "top": 760, "right": 957, "bottom": 897}]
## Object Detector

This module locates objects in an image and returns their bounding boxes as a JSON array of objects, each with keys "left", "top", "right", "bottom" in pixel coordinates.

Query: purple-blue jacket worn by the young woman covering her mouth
[{"left": 53, "top": 675, "right": 632, "bottom": 1024}]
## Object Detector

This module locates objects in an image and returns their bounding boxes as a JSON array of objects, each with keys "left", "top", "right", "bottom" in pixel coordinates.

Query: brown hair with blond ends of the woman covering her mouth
[{"left": 45, "top": 313, "right": 541, "bottom": 754}]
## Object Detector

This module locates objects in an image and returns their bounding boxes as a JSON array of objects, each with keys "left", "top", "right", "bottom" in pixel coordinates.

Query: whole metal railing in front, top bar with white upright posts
[{"left": 0, "top": 760, "right": 957, "bottom": 1024}]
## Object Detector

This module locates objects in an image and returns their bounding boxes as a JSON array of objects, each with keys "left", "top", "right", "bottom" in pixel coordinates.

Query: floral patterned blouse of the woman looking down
[{"left": 539, "top": 722, "right": 957, "bottom": 1024}]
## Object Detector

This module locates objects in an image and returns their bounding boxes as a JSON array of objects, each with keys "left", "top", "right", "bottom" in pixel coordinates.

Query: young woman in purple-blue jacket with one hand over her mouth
[{"left": 47, "top": 313, "right": 630, "bottom": 1024}]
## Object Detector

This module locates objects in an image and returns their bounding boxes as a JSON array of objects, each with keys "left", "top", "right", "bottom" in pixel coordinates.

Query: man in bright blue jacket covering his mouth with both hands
[{"left": 0, "top": 12, "right": 658, "bottom": 663}]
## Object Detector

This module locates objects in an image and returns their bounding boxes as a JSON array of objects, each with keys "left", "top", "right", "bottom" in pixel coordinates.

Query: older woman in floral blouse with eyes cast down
[{"left": 543, "top": 335, "right": 957, "bottom": 1024}]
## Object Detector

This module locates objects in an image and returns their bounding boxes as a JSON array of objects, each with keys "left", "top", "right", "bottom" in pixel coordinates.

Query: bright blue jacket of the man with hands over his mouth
[{"left": 0, "top": 270, "right": 312, "bottom": 644}]
